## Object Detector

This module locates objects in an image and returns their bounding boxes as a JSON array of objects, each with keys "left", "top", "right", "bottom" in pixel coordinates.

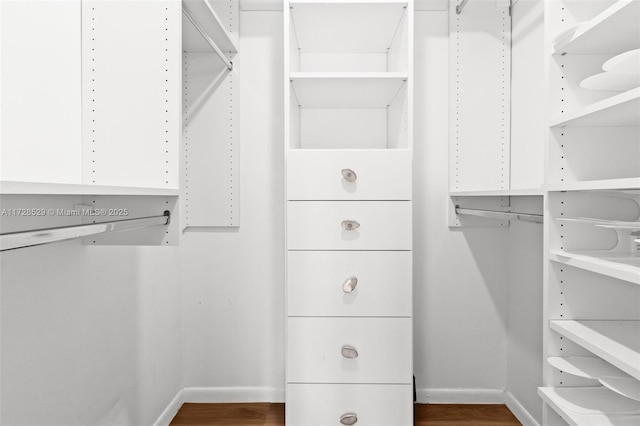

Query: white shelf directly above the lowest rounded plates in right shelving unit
[{"left": 549, "top": 320, "right": 640, "bottom": 380}]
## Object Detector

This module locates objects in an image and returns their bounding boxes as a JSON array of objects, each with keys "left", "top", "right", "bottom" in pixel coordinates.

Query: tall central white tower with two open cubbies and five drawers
[{"left": 284, "top": 0, "right": 413, "bottom": 426}]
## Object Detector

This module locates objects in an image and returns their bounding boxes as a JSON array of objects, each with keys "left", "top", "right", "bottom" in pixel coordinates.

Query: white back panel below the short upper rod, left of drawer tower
[{"left": 182, "top": 52, "right": 240, "bottom": 226}]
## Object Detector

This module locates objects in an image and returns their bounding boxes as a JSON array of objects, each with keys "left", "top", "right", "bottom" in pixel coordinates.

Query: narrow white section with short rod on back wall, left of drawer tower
[{"left": 181, "top": 0, "right": 240, "bottom": 228}]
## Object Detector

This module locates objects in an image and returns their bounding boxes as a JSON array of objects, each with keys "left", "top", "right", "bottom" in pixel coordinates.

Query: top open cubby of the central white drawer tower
[{"left": 289, "top": 0, "right": 408, "bottom": 72}]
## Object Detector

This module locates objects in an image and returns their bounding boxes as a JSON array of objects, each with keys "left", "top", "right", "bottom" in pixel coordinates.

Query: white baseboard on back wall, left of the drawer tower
[{"left": 182, "top": 387, "right": 284, "bottom": 403}]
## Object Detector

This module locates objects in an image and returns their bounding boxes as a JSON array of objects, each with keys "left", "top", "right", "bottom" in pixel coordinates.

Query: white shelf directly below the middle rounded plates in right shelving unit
[{"left": 549, "top": 250, "right": 640, "bottom": 284}]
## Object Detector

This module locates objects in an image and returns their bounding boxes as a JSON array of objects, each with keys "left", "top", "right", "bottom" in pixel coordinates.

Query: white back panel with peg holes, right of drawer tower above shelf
[{"left": 449, "top": 1, "right": 511, "bottom": 192}]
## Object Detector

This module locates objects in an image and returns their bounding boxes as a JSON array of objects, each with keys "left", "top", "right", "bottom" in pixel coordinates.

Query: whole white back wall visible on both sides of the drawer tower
[{"left": 182, "top": 11, "right": 507, "bottom": 401}]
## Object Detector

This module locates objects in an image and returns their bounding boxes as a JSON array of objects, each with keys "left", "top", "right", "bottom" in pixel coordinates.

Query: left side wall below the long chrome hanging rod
[{"left": 0, "top": 240, "right": 182, "bottom": 426}]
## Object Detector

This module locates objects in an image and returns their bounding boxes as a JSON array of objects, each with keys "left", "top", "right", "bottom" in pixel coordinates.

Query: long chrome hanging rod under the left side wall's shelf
[{"left": 0, "top": 210, "right": 170, "bottom": 251}]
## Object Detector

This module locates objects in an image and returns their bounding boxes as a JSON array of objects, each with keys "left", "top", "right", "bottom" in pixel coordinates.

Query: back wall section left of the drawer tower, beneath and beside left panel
[{"left": 182, "top": 11, "right": 285, "bottom": 401}]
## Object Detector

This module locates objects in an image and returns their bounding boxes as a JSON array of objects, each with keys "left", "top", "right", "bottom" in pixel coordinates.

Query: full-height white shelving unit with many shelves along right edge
[{"left": 539, "top": 0, "right": 640, "bottom": 426}]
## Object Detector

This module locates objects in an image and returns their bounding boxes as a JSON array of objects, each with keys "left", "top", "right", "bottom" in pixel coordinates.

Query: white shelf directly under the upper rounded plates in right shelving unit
[{"left": 550, "top": 87, "right": 640, "bottom": 127}]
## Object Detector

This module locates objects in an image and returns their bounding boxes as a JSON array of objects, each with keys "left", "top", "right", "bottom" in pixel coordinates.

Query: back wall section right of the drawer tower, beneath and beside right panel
[{"left": 413, "top": 11, "right": 507, "bottom": 402}]
